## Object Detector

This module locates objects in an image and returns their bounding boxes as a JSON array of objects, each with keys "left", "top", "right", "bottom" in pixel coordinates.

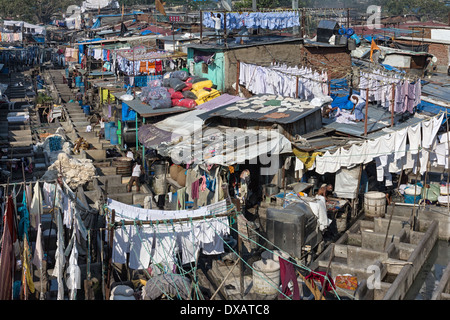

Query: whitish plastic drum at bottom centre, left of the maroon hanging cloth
[{"left": 252, "top": 259, "right": 281, "bottom": 295}]
